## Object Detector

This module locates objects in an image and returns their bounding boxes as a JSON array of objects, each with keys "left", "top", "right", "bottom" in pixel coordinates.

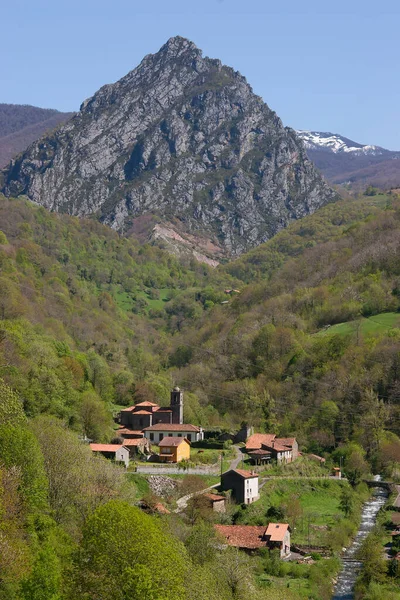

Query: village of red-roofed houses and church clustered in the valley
[{"left": 85, "top": 387, "right": 397, "bottom": 564}]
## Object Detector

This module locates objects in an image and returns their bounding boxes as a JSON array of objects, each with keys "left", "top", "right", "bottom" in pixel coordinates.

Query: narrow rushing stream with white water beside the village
[{"left": 332, "top": 475, "right": 388, "bottom": 600}]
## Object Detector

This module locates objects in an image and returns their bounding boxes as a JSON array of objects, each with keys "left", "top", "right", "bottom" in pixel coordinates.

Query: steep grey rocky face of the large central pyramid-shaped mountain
[{"left": 2, "top": 37, "right": 336, "bottom": 255}]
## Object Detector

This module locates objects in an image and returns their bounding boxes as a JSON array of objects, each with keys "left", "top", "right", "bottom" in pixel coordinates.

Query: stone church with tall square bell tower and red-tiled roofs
[{"left": 120, "top": 387, "right": 183, "bottom": 431}]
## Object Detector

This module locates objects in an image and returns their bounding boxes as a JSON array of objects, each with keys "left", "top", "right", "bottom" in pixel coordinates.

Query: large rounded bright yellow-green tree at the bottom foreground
[{"left": 75, "top": 500, "right": 187, "bottom": 600}]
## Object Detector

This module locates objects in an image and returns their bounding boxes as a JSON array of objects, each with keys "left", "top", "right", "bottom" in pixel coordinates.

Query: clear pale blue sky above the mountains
[{"left": 0, "top": 0, "right": 400, "bottom": 150}]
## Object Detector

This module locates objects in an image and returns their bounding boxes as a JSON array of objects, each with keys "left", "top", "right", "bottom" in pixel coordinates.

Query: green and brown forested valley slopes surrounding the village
[{"left": 0, "top": 193, "right": 400, "bottom": 600}]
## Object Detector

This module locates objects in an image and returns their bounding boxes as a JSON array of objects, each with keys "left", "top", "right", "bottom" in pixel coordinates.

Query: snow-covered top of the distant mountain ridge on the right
[{"left": 296, "top": 130, "right": 390, "bottom": 156}]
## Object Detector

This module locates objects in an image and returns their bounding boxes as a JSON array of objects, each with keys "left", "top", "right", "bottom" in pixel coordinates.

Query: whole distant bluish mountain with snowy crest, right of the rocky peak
[{"left": 296, "top": 130, "right": 400, "bottom": 190}]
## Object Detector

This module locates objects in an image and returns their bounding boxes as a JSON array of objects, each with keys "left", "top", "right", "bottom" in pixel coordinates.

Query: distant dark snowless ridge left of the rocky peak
[{"left": 0, "top": 103, "right": 73, "bottom": 168}]
